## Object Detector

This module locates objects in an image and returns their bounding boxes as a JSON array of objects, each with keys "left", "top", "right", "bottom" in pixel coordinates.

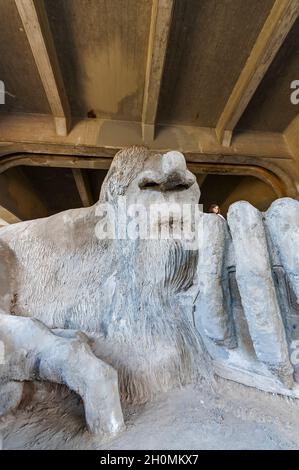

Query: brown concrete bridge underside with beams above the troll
[{"left": 0, "top": 0, "right": 299, "bottom": 225}]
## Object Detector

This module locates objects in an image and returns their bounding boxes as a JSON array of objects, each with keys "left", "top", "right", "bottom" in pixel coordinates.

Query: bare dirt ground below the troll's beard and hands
[{"left": 0, "top": 379, "right": 299, "bottom": 450}]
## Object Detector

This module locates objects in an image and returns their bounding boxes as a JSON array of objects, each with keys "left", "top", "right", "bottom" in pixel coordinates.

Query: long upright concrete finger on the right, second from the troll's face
[{"left": 228, "top": 201, "right": 293, "bottom": 386}]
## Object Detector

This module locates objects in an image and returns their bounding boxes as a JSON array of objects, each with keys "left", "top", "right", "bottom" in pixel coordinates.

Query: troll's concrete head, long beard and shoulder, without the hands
[{"left": 0, "top": 148, "right": 204, "bottom": 408}]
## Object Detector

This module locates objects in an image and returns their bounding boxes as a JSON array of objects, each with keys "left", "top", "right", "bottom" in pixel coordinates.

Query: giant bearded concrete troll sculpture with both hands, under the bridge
[{"left": 0, "top": 147, "right": 299, "bottom": 434}]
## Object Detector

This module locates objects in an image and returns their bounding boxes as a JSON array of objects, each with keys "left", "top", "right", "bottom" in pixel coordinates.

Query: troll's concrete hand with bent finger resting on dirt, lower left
[{"left": 0, "top": 312, "right": 124, "bottom": 436}]
